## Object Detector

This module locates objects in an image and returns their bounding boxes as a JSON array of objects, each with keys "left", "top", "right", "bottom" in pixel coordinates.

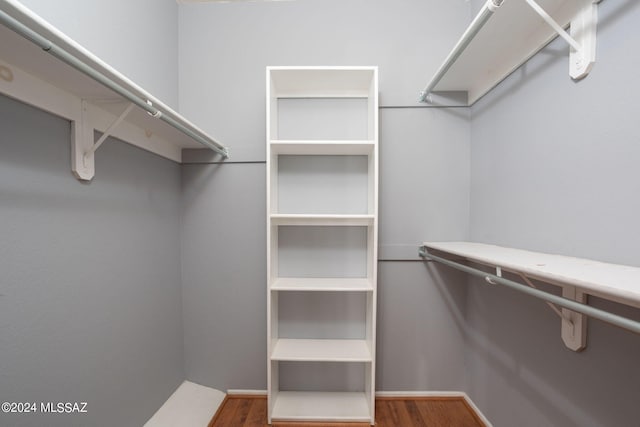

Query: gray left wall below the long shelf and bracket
[{"left": 0, "top": 97, "right": 184, "bottom": 427}]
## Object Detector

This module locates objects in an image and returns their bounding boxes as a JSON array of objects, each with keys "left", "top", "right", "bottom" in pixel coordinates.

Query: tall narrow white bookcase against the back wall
[{"left": 267, "top": 67, "right": 378, "bottom": 425}]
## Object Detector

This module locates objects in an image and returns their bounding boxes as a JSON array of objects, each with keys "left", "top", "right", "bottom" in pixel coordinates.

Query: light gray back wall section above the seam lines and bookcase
[{"left": 179, "top": 0, "right": 469, "bottom": 161}]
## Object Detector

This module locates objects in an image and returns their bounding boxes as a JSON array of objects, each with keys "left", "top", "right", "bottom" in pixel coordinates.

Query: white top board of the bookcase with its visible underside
[{"left": 267, "top": 66, "right": 376, "bottom": 98}]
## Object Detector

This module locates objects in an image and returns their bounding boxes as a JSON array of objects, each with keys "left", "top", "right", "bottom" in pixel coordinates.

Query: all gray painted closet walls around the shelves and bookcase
[{"left": 8, "top": 0, "right": 640, "bottom": 427}]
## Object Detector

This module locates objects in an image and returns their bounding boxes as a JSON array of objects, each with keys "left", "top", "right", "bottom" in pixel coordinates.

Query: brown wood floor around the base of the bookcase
[{"left": 209, "top": 396, "right": 485, "bottom": 427}]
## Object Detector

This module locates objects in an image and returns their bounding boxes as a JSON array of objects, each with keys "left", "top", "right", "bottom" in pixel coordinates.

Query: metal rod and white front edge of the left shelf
[{"left": 0, "top": 0, "right": 229, "bottom": 158}]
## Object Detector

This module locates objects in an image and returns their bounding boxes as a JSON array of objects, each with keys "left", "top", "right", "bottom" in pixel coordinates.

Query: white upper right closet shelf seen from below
[{"left": 423, "top": 0, "right": 595, "bottom": 105}]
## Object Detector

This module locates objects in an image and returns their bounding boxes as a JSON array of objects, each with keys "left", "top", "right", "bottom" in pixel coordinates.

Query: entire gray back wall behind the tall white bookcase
[{"left": 179, "top": 0, "right": 470, "bottom": 390}]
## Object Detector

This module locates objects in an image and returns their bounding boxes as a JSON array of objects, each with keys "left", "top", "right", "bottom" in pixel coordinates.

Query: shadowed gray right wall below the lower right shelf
[{"left": 465, "top": 270, "right": 640, "bottom": 427}]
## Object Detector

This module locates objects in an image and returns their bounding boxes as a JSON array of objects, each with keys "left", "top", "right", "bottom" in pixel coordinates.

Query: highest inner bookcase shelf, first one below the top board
[{"left": 270, "top": 140, "right": 375, "bottom": 156}]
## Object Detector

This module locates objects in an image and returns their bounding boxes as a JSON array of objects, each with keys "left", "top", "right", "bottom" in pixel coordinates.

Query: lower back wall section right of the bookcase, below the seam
[{"left": 376, "top": 262, "right": 467, "bottom": 391}]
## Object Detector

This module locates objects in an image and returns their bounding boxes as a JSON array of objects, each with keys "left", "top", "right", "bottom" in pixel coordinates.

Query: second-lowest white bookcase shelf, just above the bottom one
[{"left": 271, "top": 338, "right": 372, "bottom": 362}]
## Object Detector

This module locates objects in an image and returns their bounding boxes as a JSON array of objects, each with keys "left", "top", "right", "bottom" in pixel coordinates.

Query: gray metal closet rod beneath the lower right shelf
[{"left": 418, "top": 246, "right": 640, "bottom": 334}]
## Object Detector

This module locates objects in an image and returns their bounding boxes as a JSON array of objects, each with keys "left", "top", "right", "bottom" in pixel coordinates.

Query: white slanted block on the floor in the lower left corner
[{"left": 144, "top": 381, "right": 225, "bottom": 427}]
